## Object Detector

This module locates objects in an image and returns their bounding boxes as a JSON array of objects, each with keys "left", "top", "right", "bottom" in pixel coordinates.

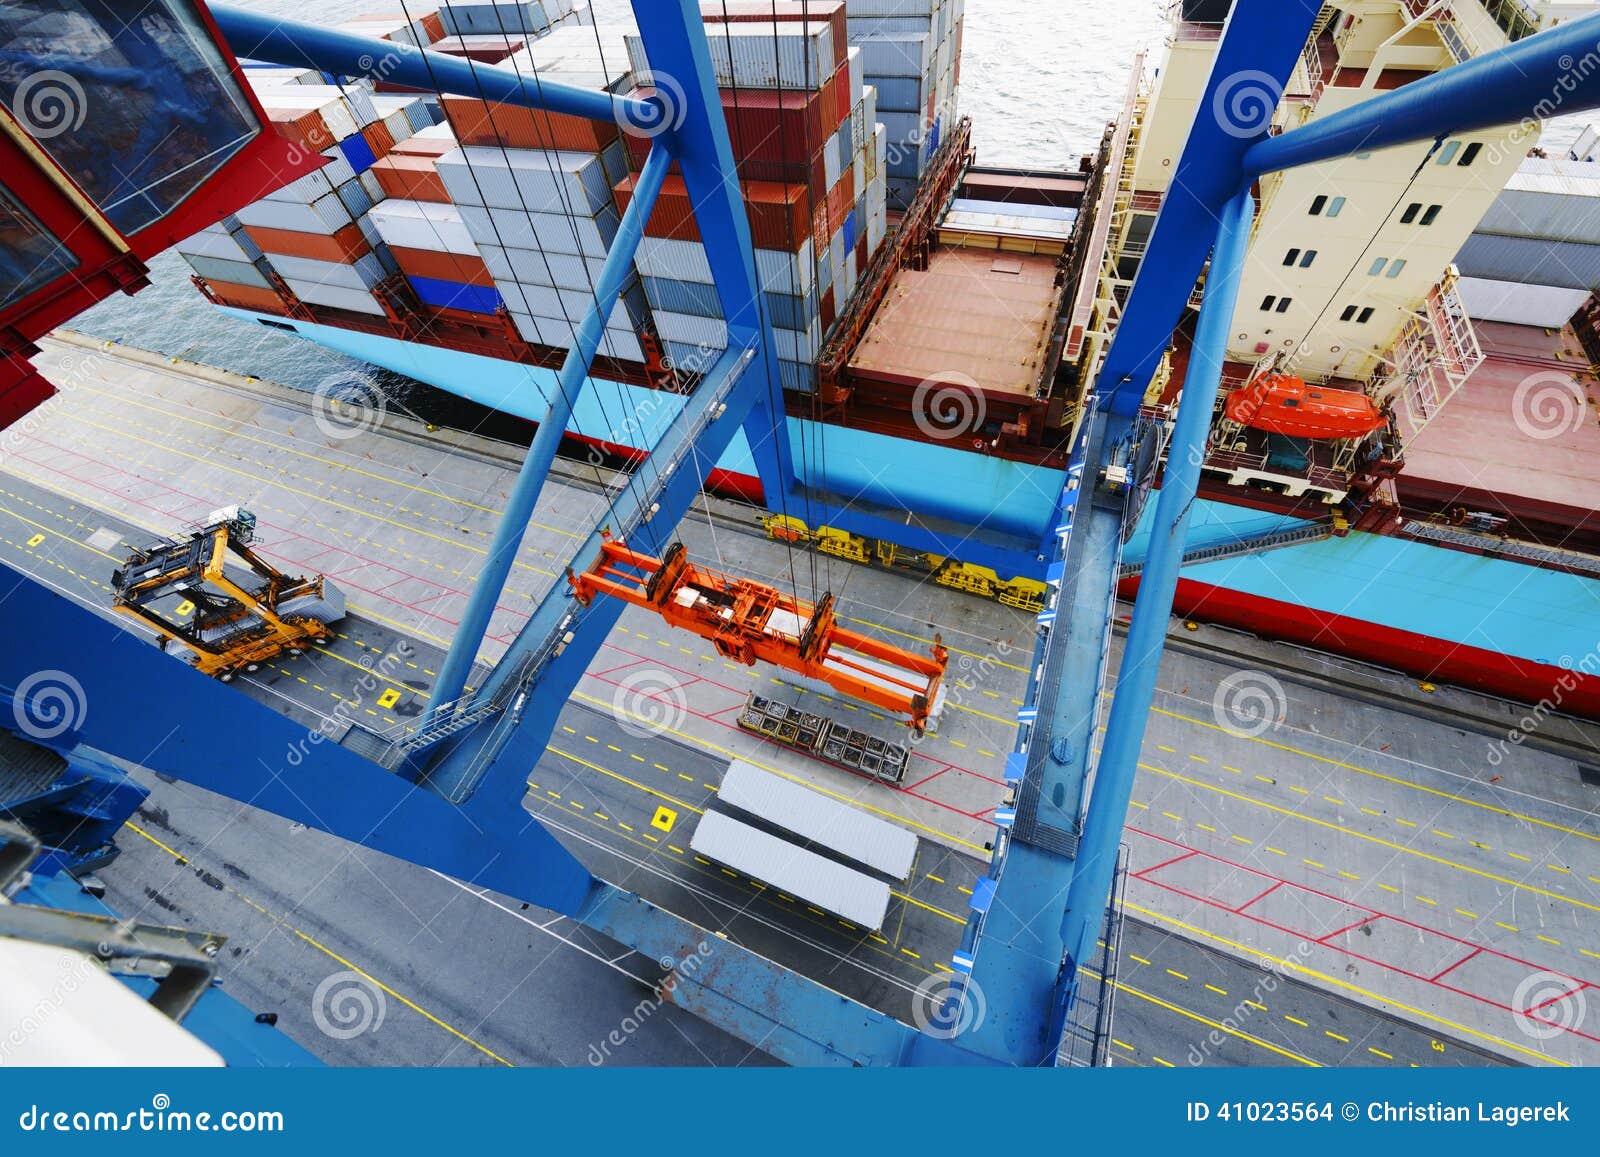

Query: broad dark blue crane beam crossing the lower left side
[{"left": 0, "top": 565, "right": 600, "bottom": 912}]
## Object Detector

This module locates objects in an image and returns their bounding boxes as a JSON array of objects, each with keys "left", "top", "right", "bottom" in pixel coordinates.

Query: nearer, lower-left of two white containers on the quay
[{"left": 690, "top": 811, "right": 890, "bottom": 931}]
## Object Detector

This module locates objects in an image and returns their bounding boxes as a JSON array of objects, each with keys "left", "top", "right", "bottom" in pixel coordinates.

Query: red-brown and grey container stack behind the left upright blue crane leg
[{"left": 614, "top": 0, "right": 882, "bottom": 390}]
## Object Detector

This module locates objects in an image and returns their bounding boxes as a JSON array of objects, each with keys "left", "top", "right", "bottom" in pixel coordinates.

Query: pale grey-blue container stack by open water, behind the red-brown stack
[{"left": 845, "top": 0, "right": 965, "bottom": 210}]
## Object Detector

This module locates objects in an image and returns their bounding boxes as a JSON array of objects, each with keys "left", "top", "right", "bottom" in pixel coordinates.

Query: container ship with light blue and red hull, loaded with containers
[{"left": 147, "top": 0, "right": 1600, "bottom": 714}]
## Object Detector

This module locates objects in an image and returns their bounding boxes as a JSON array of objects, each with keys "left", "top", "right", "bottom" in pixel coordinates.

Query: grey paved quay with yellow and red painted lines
[{"left": 0, "top": 332, "right": 1600, "bottom": 1066}]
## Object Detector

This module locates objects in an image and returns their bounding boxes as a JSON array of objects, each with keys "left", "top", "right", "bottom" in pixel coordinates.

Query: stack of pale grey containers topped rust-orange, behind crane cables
[{"left": 434, "top": 27, "right": 648, "bottom": 362}]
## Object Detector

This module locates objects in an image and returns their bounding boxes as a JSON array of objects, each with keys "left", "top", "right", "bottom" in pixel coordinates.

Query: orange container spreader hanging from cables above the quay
[{"left": 566, "top": 533, "right": 950, "bottom": 735}]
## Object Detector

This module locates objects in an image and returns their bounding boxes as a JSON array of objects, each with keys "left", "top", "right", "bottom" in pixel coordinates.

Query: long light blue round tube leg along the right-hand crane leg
[{"left": 1061, "top": 189, "right": 1254, "bottom": 979}]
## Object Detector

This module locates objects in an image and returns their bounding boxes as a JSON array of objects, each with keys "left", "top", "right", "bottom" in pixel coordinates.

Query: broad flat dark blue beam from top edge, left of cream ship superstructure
[{"left": 1096, "top": 0, "right": 1322, "bottom": 416}]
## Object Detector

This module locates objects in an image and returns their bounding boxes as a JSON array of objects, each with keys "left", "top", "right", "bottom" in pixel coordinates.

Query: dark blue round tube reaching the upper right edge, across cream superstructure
[{"left": 1243, "top": 13, "right": 1600, "bottom": 179}]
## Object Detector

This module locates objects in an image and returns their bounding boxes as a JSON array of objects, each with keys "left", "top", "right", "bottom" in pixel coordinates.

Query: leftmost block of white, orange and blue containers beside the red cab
[{"left": 186, "top": 70, "right": 430, "bottom": 317}]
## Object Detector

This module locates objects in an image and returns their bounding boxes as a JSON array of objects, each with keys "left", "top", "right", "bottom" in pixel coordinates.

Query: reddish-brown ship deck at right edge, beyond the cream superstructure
[{"left": 1397, "top": 322, "right": 1600, "bottom": 552}]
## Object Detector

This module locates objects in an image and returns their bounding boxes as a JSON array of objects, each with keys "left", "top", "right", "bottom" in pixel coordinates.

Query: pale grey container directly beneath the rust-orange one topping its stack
[{"left": 437, "top": 147, "right": 613, "bottom": 218}]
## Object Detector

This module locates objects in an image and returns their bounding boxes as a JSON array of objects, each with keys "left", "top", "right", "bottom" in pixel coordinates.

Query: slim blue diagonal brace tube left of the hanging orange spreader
[{"left": 427, "top": 141, "right": 672, "bottom": 719}]
